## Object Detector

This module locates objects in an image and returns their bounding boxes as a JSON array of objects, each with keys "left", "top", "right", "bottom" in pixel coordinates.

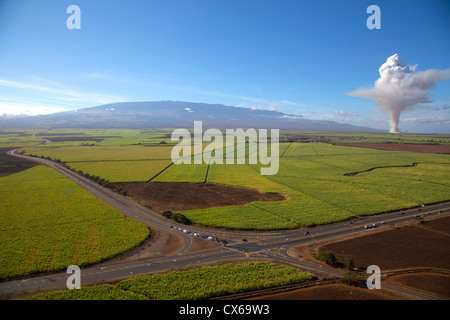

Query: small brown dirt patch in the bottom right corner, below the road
[{"left": 385, "top": 272, "right": 450, "bottom": 299}]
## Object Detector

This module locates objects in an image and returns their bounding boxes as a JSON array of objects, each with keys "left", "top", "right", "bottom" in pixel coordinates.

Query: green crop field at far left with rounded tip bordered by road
[{"left": 0, "top": 166, "right": 149, "bottom": 279}]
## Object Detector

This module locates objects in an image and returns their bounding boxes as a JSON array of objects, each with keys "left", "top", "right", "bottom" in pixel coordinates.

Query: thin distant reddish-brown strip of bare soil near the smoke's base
[{"left": 334, "top": 142, "right": 450, "bottom": 154}]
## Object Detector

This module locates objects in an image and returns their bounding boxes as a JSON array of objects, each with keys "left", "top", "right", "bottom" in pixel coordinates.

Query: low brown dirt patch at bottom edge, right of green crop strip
[{"left": 249, "top": 284, "right": 398, "bottom": 300}]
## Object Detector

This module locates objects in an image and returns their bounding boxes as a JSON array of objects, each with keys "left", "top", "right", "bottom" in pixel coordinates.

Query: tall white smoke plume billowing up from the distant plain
[{"left": 348, "top": 54, "right": 450, "bottom": 133}]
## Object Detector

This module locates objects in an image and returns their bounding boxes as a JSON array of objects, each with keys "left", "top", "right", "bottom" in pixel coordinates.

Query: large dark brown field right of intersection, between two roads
[{"left": 320, "top": 216, "right": 450, "bottom": 271}]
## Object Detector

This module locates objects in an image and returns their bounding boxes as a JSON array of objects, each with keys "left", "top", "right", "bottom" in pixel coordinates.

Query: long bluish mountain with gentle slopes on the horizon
[{"left": 0, "top": 101, "right": 378, "bottom": 132}]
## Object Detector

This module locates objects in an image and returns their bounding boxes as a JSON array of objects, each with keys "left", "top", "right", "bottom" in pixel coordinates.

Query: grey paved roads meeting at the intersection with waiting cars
[{"left": 0, "top": 141, "right": 450, "bottom": 299}]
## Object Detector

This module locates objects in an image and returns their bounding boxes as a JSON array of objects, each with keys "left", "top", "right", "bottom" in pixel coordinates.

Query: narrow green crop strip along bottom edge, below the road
[{"left": 29, "top": 262, "right": 316, "bottom": 300}]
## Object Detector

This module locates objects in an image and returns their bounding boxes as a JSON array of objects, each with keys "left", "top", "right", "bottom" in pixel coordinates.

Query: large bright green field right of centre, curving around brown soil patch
[{"left": 178, "top": 143, "right": 450, "bottom": 230}]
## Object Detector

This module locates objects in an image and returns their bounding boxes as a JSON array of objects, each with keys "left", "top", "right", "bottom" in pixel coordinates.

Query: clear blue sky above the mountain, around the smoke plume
[{"left": 0, "top": 0, "right": 450, "bottom": 133}]
